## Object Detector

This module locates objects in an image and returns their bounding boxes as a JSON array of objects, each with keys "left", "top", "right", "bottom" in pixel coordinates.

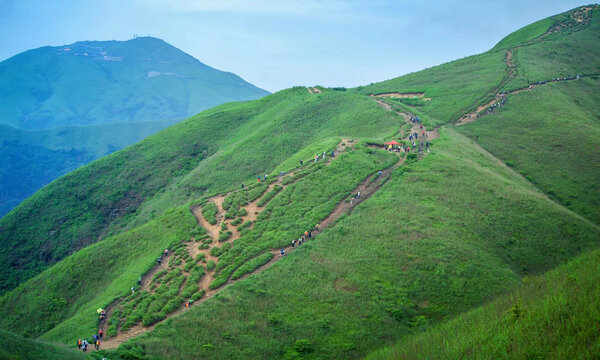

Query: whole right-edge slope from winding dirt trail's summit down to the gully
[{"left": 461, "top": 6, "right": 600, "bottom": 224}]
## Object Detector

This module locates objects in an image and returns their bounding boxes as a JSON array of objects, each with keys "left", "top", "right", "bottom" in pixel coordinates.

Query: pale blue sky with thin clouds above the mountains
[{"left": 0, "top": 0, "right": 584, "bottom": 91}]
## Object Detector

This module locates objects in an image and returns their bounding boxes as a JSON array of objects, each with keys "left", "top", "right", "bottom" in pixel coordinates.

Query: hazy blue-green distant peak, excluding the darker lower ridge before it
[{"left": 0, "top": 37, "right": 268, "bottom": 130}]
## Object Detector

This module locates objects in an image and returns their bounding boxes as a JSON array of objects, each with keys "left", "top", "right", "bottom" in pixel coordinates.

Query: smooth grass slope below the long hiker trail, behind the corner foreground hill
[{"left": 105, "top": 131, "right": 600, "bottom": 359}]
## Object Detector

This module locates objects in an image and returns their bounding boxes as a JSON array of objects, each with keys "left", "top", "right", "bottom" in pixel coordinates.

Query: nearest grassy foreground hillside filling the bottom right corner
[{"left": 367, "top": 250, "right": 600, "bottom": 360}]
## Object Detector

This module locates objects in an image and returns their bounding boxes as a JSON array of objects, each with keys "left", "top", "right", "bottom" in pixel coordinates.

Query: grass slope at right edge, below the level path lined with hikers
[{"left": 460, "top": 78, "right": 600, "bottom": 224}]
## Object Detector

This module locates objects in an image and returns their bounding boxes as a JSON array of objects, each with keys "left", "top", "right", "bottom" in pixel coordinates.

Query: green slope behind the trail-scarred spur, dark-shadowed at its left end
[{"left": 0, "top": 88, "right": 402, "bottom": 291}]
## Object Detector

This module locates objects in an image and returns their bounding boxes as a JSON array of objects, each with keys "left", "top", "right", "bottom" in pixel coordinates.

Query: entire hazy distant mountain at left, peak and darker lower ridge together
[{"left": 0, "top": 37, "right": 268, "bottom": 216}]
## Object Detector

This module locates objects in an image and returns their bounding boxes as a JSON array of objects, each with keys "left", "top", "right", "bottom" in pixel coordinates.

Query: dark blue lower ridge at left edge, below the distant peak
[{"left": 0, "top": 120, "right": 177, "bottom": 217}]
